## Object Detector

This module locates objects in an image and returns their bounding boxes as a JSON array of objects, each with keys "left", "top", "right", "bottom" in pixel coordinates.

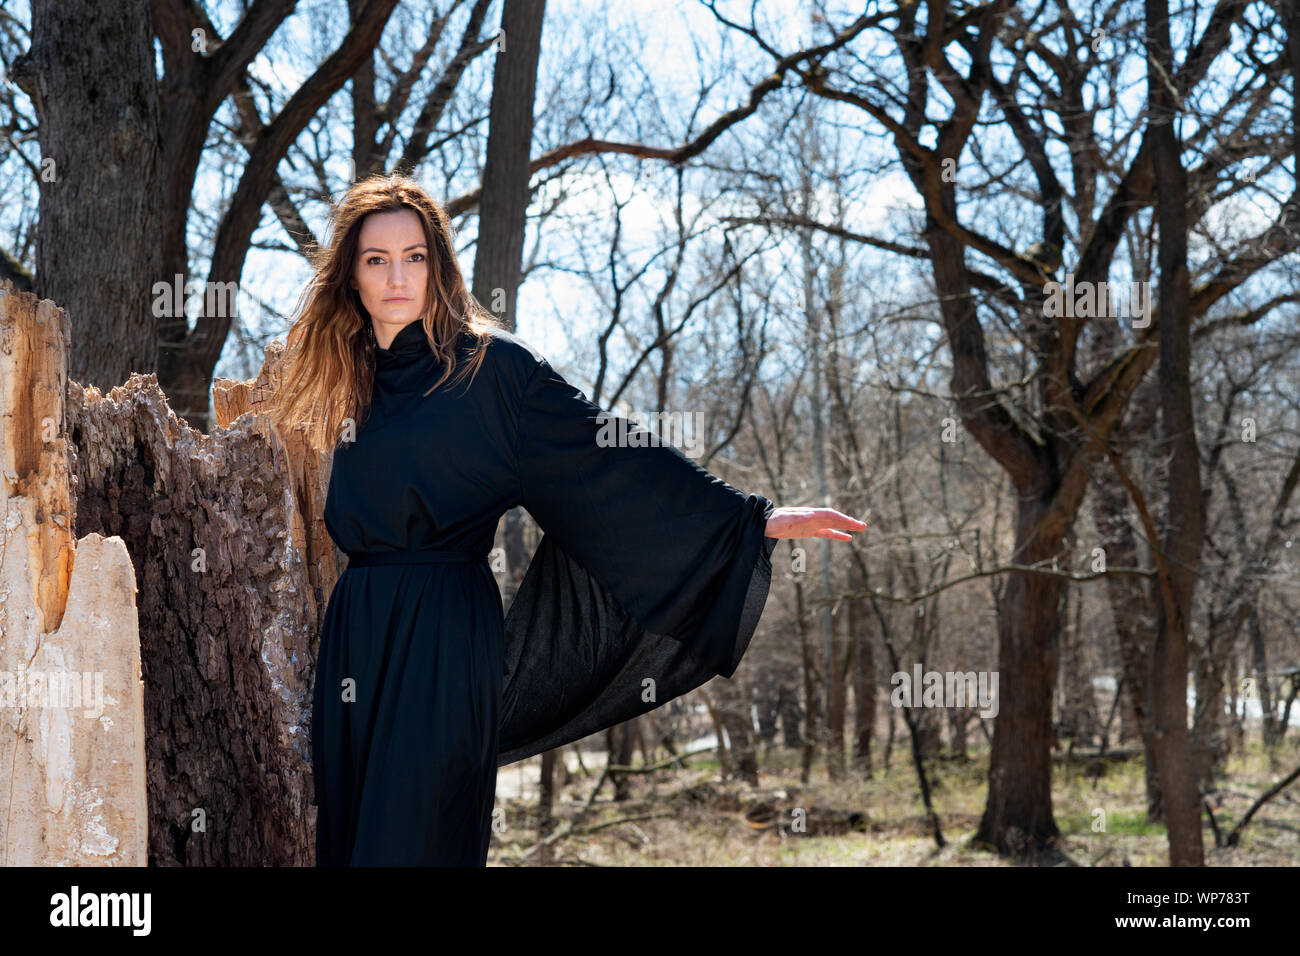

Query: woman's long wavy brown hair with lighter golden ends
[{"left": 268, "top": 173, "right": 501, "bottom": 451}]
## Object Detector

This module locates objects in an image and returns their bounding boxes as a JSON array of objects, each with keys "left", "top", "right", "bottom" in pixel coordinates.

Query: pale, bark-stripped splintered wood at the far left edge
[{"left": 0, "top": 282, "right": 148, "bottom": 866}]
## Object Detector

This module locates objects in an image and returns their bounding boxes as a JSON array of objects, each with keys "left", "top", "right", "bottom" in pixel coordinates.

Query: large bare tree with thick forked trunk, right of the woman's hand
[{"left": 780, "top": 0, "right": 1295, "bottom": 852}]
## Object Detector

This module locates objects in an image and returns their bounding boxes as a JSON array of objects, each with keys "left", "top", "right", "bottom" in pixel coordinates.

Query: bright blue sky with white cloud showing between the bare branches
[{"left": 0, "top": 0, "right": 1287, "bottom": 408}]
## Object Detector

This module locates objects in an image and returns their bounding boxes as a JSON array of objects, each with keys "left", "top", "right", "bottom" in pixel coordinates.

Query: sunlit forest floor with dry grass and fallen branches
[{"left": 488, "top": 739, "right": 1300, "bottom": 866}]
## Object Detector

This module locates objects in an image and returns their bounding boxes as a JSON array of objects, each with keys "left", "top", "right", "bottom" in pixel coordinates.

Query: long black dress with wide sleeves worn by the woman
[{"left": 312, "top": 321, "right": 776, "bottom": 866}]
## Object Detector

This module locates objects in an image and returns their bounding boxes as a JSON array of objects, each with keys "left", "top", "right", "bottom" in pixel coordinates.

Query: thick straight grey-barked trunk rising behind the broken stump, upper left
[{"left": 13, "top": 0, "right": 162, "bottom": 389}]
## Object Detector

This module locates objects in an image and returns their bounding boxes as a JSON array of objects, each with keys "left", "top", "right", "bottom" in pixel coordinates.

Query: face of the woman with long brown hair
[{"left": 352, "top": 209, "right": 429, "bottom": 349}]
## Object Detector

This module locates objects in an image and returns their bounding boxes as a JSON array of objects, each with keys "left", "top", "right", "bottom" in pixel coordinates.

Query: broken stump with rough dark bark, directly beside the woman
[{"left": 0, "top": 278, "right": 341, "bottom": 866}]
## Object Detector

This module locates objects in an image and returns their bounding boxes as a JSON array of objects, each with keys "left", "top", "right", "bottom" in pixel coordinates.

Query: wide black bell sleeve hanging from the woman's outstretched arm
[{"left": 497, "top": 359, "right": 776, "bottom": 766}]
